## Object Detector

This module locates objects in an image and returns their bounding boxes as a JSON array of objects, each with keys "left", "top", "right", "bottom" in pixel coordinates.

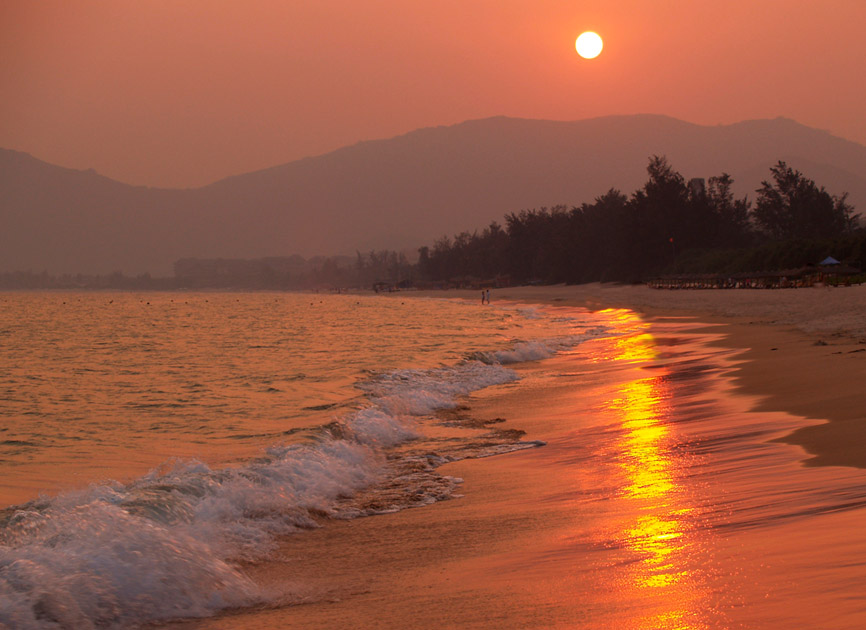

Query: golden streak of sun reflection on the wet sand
[{"left": 610, "top": 324, "right": 705, "bottom": 629}]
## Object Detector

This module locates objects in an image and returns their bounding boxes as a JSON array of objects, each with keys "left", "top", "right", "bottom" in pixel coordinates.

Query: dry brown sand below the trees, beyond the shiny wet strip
[{"left": 390, "top": 283, "right": 866, "bottom": 468}]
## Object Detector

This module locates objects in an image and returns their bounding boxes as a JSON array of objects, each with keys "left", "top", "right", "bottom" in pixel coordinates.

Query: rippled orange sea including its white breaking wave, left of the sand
[{"left": 0, "top": 293, "right": 603, "bottom": 628}]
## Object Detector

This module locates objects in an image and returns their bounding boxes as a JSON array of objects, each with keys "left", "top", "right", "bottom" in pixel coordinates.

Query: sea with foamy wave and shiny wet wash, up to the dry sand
[{"left": 0, "top": 292, "right": 866, "bottom": 630}]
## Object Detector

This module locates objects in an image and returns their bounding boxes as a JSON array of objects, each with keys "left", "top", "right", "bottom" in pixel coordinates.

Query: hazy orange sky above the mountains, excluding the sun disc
[{"left": 0, "top": 0, "right": 866, "bottom": 186}]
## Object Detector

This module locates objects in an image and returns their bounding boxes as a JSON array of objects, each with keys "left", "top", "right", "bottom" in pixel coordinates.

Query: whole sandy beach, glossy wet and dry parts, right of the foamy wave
[{"left": 172, "top": 285, "right": 866, "bottom": 629}]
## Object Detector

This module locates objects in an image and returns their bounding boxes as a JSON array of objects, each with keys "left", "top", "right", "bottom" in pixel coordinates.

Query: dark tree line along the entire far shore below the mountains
[{"left": 0, "top": 156, "right": 866, "bottom": 290}]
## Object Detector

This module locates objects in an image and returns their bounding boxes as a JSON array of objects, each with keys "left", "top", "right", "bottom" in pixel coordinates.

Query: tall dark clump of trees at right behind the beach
[{"left": 418, "top": 156, "right": 866, "bottom": 284}]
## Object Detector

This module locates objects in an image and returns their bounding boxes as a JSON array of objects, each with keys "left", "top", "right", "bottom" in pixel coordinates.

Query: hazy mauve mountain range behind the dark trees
[{"left": 0, "top": 115, "right": 866, "bottom": 275}]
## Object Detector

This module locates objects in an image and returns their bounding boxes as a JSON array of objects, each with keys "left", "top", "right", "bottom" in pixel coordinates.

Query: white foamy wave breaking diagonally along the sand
[{"left": 0, "top": 328, "right": 604, "bottom": 630}]
